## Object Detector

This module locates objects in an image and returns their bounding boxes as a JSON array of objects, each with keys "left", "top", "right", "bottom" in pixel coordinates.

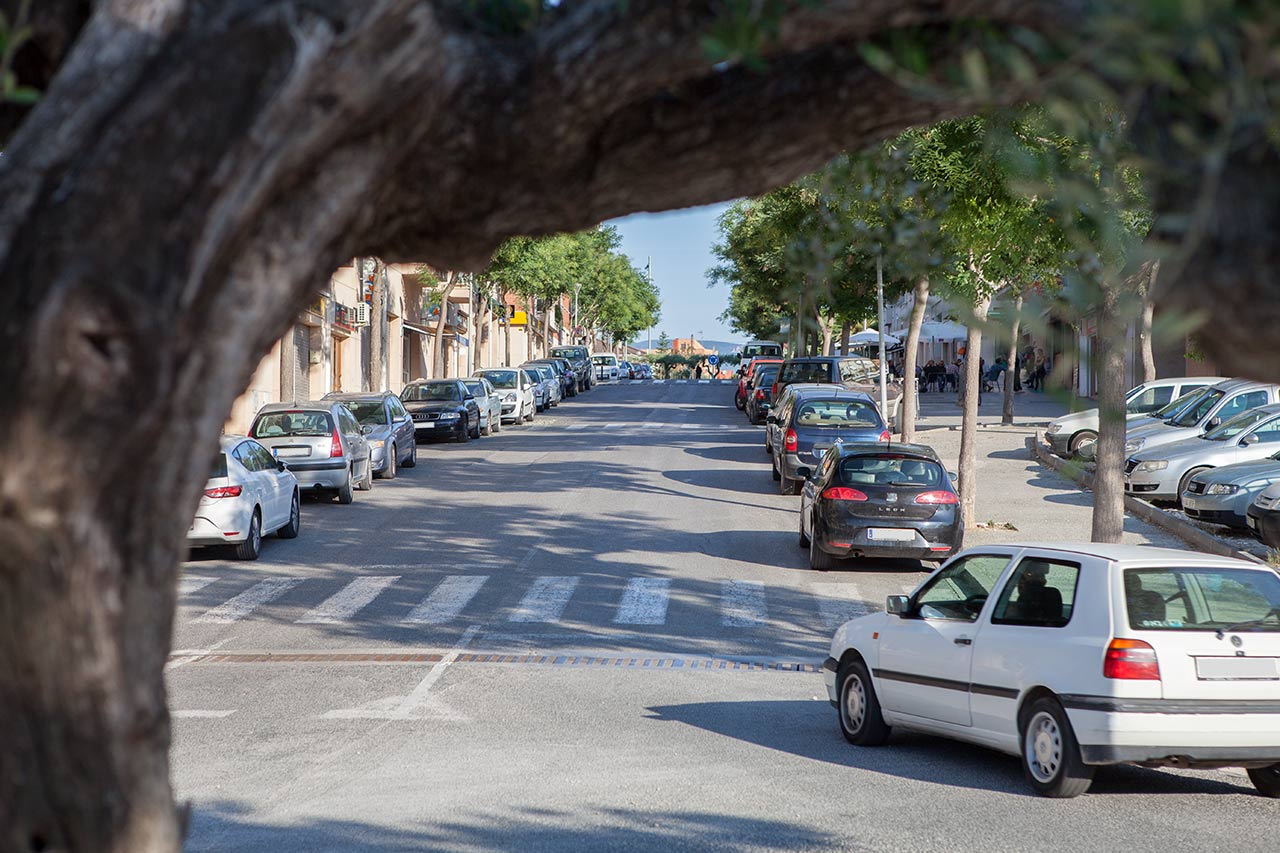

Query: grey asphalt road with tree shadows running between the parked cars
[{"left": 169, "top": 384, "right": 1277, "bottom": 850}]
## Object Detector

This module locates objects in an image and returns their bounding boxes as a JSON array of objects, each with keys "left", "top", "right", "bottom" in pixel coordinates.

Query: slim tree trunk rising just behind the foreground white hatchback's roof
[{"left": 1091, "top": 280, "right": 1126, "bottom": 543}]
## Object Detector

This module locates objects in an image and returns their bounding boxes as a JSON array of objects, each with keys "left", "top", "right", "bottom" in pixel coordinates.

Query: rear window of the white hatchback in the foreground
[{"left": 1124, "top": 567, "right": 1280, "bottom": 630}]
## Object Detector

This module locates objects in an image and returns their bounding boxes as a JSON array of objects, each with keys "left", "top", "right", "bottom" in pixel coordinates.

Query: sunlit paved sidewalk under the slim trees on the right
[{"left": 901, "top": 392, "right": 1187, "bottom": 548}]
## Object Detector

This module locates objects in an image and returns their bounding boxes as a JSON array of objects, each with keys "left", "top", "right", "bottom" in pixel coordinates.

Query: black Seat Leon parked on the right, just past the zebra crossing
[{"left": 797, "top": 443, "right": 964, "bottom": 571}]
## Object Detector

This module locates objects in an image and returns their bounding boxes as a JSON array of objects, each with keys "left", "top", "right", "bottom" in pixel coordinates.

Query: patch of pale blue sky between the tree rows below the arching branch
[{"left": 607, "top": 204, "right": 745, "bottom": 347}]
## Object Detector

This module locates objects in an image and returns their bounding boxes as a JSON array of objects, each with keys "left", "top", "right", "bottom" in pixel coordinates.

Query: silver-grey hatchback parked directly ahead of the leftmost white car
[{"left": 248, "top": 400, "right": 374, "bottom": 503}]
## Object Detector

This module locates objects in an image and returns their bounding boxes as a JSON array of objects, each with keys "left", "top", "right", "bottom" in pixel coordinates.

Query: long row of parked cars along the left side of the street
[{"left": 187, "top": 363, "right": 594, "bottom": 560}]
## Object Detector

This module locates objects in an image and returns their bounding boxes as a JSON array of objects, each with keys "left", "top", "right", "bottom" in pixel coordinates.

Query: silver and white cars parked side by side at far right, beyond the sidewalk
[{"left": 1047, "top": 377, "right": 1280, "bottom": 547}]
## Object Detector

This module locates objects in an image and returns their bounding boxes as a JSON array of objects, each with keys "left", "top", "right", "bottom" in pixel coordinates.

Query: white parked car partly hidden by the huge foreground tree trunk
[{"left": 187, "top": 435, "right": 302, "bottom": 560}]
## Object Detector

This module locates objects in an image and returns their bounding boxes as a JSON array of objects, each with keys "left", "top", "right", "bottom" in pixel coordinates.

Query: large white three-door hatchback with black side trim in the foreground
[{"left": 823, "top": 543, "right": 1280, "bottom": 797}]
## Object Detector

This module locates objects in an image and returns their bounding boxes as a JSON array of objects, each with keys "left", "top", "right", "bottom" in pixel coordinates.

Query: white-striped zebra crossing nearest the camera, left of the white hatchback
[{"left": 179, "top": 574, "right": 914, "bottom": 629}]
